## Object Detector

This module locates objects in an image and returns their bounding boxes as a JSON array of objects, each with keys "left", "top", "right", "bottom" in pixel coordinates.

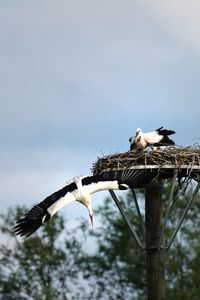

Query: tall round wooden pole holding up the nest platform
[{"left": 145, "top": 180, "right": 165, "bottom": 300}]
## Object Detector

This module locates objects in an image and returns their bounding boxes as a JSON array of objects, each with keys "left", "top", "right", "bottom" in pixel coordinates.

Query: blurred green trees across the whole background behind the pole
[{"left": 0, "top": 184, "right": 200, "bottom": 300}]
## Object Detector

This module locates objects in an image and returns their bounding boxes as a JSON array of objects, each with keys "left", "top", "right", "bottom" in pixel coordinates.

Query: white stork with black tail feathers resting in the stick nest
[{"left": 129, "top": 127, "right": 175, "bottom": 150}]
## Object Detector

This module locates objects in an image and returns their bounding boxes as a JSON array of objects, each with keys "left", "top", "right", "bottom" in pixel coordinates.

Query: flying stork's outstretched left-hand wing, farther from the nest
[{"left": 14, "top": 182, "right": 77, "bottom": 237}]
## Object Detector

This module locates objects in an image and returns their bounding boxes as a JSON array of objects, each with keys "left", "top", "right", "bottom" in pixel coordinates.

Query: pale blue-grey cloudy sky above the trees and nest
[{"left": 0, "top": 0, "right": 200, "bottom": 229}]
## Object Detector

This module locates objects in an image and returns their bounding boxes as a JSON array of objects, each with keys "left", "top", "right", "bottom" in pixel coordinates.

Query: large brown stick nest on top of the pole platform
[{"left": 92, "top": 145, "right": 200, "bottom": 186}]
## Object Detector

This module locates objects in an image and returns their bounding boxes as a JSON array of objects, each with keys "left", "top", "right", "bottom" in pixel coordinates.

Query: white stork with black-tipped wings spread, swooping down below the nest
[{"left": 14, "top": 172, "right": 129, "bottom": 237}]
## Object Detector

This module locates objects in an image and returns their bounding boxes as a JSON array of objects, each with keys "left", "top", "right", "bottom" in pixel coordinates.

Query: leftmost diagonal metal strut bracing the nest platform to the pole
[{"left": 109, "top": 190, "right": 145, "bottom": 249}]
